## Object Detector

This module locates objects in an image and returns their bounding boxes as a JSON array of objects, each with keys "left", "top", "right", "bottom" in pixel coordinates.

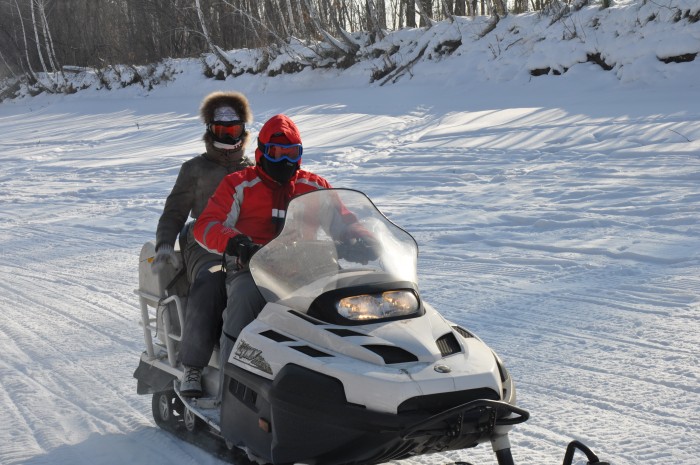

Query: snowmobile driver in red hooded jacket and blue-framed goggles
[{"left": 189, "top": 111, "right": 331, "bottom": 397}]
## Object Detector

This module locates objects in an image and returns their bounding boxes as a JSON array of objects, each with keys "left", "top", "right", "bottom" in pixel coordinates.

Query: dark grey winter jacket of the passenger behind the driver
[{"left": 156, "top": 142, "right": 253, "bottom": 282}]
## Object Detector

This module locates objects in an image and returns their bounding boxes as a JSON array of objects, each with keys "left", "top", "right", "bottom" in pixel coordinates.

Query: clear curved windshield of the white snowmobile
[{"left": 250, "top": 189, "right": 418, "bottom": 312}]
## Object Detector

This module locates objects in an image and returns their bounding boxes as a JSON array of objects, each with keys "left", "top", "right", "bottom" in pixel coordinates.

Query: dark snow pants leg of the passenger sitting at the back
[{"left": 180, "top": 259, "right": 226, "bottom": 368}]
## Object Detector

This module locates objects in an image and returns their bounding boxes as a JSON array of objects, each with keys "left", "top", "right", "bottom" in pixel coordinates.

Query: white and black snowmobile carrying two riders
[{"left": 134, "top": 189, "right": 602, "bottom": 465}]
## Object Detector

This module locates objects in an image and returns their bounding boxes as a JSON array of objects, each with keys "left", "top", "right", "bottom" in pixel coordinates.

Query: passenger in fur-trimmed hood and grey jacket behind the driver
[{"left": 152, "top": 92, "right": 253, "bottom": 397}]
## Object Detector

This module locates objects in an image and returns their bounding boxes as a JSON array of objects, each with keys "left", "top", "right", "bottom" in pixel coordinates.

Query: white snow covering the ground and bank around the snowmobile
[{"left": 0, "top": 0, "right": 700, "bottom": 465}]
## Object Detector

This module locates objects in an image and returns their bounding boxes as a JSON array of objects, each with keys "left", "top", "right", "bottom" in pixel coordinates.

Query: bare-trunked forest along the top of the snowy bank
[{"left": 0, "top": 0, "right": 609, "bottom": 92}]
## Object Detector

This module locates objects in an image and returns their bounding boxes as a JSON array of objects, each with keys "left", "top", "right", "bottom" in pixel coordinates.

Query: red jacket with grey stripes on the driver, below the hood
[{"left": 194, "top": 166, "right": 331, "bottom": 253}]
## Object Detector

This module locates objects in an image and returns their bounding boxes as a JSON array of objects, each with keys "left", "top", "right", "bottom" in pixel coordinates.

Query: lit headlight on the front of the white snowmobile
[{"left": 335, "top": 291, "right": 419, "bottom": 321}]
